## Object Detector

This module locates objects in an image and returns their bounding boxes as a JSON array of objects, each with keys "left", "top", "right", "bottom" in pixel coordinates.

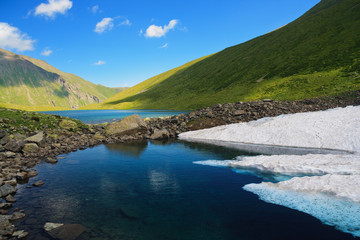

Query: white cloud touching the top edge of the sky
[{"left": 34, "top": 0, "right": 72, "bottom": 18}]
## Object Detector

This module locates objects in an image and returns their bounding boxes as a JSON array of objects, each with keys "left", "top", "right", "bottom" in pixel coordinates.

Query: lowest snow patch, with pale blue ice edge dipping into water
[{"left": 244, "top": 175, "right": 360, "bottom": 237}]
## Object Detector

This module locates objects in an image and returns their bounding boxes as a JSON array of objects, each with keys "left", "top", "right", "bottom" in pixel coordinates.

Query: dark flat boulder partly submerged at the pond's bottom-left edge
[{"left": 48, "top": 224, "right": 86, "bottom": 240}]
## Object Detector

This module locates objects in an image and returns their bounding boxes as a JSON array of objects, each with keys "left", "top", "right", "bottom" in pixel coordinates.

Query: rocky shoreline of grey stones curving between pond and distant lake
[{"left": 0, "top": 91, "right": 360, "bottom": 239}]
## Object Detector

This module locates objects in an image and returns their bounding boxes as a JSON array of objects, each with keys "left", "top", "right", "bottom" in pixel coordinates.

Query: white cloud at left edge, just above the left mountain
[{"left": 0, "top": 22, "right": 35, "bottom": 51}]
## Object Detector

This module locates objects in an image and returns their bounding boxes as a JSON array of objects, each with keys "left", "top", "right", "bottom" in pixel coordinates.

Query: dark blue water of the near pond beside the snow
[{"left": 14, "top": 141, "right": 354, "bottom": 240}]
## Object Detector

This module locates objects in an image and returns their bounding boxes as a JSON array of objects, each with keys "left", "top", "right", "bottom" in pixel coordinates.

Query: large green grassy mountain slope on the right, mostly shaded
[{"left": 85, "top": 0, "right": 360, "bottom": 109}]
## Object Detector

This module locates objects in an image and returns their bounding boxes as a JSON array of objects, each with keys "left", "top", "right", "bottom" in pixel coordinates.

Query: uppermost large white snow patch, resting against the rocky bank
[{"left": 179, "top": 106, "right": 360, "bottom": 151}]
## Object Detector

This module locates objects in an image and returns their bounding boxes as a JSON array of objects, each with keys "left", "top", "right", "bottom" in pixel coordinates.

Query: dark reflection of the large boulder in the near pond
[{"left": 105, "top": 141, "right": 148, "bottom": 157}]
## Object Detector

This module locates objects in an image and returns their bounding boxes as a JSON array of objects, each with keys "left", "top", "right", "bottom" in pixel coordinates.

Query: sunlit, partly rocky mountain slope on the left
[{"left": 0, "top": 49, "right": 125, "bottom": 110}]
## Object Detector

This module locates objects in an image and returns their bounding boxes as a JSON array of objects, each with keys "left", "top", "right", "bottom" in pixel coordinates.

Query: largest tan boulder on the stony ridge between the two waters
[{"left": 105, "top": 114, "right": 147, "bottom": 136}]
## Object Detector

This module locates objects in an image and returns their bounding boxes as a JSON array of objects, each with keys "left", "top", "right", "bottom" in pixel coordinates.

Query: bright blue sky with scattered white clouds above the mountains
[{"left": 0, "top": 0, "right": 319, "bottom": 87}]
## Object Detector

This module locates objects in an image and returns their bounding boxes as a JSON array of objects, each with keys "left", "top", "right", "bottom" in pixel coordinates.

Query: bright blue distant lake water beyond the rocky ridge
[{"left": 38, "top": 110, "right": 187, "bottom": 124}]
